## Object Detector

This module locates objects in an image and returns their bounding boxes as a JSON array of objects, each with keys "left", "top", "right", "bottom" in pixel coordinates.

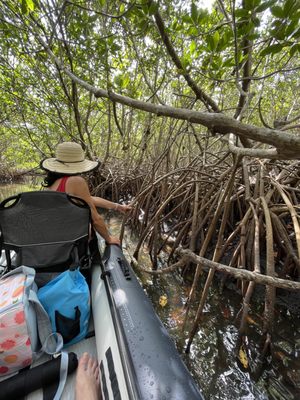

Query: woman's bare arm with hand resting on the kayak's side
[{"left": 66, "top": 176, "right": 120, "bottom": 244}]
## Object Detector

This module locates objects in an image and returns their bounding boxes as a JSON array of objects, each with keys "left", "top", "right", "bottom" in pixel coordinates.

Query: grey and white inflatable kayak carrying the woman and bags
[{"left": 0, "top": 192, "right": 203, "bottom": 400}]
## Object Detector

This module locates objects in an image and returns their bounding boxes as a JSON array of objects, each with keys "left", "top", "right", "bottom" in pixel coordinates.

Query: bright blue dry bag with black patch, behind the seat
[{"left": 38, "top": 269, "right": 90, "bottom": 347}]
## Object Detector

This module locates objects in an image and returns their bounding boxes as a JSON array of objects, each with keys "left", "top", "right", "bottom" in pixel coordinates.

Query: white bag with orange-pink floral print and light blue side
[{"left": 0, "top": 266, "right": 62, "bottom": 377}]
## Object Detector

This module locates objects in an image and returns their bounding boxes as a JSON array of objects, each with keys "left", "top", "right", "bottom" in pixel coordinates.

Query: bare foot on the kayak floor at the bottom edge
[{"left": 75, "top": 353, "right": 101, "bottom": 400}]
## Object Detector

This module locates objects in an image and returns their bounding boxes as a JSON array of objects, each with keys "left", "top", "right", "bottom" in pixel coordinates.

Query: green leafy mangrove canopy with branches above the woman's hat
[{"left": 0, "top": 0, "right": 300, "bottom": 167}]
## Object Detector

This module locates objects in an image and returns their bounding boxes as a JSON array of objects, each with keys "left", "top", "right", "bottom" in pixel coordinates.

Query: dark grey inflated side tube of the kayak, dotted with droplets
[{"left": 92, "top": 245, "right": 202, "bottom": 400}]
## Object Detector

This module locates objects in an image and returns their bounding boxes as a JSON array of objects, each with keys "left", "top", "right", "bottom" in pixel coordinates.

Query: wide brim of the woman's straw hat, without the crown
[{"left": 41, "top": 158, "right": 99, "bottom": 175}]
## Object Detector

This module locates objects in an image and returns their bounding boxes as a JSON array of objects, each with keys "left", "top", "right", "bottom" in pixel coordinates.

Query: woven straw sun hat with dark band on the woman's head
[{"left": 41, "top": 142, "right": 99, "bottom": 175}]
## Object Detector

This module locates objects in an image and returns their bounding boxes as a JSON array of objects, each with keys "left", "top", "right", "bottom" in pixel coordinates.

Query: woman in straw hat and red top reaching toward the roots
[{"left": 41, "top": 142, "right": 131, "bottom": 244}]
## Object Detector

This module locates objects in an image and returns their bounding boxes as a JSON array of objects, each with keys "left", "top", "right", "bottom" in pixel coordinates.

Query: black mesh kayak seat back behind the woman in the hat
[{"left": 0, "top": 191, "right": 90, "bottom": 268}]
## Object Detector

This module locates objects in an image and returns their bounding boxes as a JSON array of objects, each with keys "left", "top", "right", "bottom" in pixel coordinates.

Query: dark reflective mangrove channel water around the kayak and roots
[{"left": 0, "top": 185, "right": 300, "bottom": 400}]
